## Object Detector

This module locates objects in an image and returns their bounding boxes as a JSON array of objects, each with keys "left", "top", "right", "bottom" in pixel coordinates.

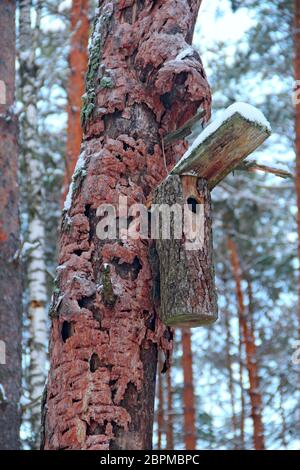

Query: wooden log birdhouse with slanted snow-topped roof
[{"left": 152, "top": 103, "right": 271, "bottom": 327}]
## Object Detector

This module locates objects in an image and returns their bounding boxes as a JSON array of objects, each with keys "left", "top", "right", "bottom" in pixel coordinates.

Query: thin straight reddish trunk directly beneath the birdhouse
[{"left": 182, "top": 328, "right": 197, "bottom": 450}]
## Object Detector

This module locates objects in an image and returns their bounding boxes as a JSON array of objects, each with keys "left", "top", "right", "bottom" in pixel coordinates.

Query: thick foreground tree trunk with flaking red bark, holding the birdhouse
[{"left": 44, "top": 0, "right": 210, "bottom": 450}]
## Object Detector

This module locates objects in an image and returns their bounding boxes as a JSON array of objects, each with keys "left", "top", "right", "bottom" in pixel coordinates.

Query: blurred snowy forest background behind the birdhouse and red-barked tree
[{"left": 0, "top": 0, "right": 300, "bottom": 450}]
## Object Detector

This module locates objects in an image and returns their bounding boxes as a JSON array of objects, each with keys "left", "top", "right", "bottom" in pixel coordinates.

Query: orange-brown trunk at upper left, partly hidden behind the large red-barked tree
[{"left": 63, "top": 0, "right": 89, "bottom": 201}]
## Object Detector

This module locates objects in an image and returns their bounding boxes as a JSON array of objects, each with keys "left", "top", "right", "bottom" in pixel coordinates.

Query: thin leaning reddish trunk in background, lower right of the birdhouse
[{"left": 228, "top": 239, "right": 264, "bottom": 450}]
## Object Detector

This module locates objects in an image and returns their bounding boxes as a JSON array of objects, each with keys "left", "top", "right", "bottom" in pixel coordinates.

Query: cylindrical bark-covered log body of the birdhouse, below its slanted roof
[{"left": 152, "top": 175, "right": 218, "bottom": 327}]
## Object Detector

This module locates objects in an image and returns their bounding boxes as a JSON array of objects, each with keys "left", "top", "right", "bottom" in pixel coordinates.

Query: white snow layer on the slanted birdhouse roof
[{"left": 174, "top": 102, "right": 271, "bottom": 170}]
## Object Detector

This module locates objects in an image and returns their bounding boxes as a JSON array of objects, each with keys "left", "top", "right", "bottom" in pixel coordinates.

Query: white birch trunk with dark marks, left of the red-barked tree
[{"left": 19, "top": 0, "right": 48, "bottom": 444}]
